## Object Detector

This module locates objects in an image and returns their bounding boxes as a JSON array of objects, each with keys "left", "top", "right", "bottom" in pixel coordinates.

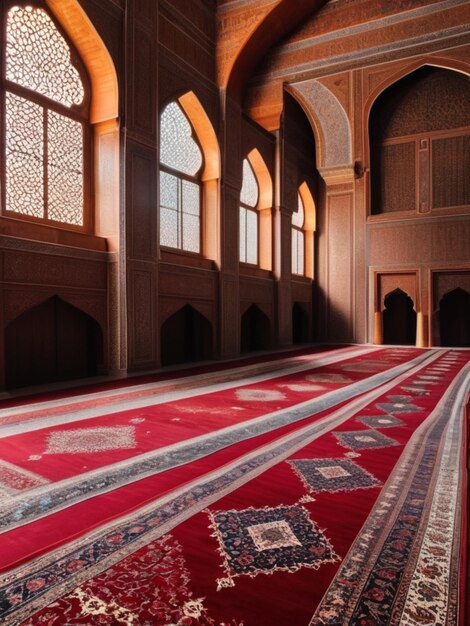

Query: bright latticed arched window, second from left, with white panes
[{"left": 160, "top": 102, "right": 203, "bottom": 253}]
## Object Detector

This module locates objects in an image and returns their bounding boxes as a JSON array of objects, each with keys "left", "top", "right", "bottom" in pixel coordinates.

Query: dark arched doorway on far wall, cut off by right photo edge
[{"left": 439, "top": 288, "right": 470, "bottom": 348}]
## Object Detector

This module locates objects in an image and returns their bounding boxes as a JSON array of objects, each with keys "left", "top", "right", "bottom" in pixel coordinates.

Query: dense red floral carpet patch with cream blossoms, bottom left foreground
[{"left": 18, "top": 535, "right": 241, "bottom": 626}]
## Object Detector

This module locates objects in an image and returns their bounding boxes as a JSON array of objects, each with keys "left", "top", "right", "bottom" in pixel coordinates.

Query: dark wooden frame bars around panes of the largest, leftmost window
[{"left": 0, "top": 0, "right": 94, "bottom": 234}]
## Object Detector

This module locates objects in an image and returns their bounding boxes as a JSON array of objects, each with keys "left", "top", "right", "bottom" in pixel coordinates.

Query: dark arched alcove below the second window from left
[{"left": 160, "top": 304, "right": 213, "bottom": 365}]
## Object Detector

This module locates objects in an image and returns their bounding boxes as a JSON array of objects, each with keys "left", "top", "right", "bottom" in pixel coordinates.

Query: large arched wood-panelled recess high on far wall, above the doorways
[{"left": 369, "top": 65, "right": 470, "bottom": 214}]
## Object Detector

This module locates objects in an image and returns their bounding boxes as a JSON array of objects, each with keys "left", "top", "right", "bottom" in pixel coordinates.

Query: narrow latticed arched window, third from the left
[{"left": 240, "top": 159, "right": 259, "bottom": 265}]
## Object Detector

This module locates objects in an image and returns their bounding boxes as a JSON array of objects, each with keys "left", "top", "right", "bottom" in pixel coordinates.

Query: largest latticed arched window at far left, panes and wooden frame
[{"left": 0, "top": 3, "right": 91, "bottom": 230}]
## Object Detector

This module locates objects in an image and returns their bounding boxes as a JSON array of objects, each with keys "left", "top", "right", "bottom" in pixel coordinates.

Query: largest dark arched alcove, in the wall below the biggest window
[{"left": 5, "top": 296, "right": 103, "bottom": 389}]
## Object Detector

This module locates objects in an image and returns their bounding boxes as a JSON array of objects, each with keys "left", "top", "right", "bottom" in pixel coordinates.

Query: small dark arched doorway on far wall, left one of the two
[{"left": 383, "top": 289, "right": 416, "bottom": 345}]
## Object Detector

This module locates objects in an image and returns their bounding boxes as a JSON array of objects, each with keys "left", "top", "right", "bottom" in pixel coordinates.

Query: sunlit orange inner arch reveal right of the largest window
[{"left": 45, "top": 0, "right": 119, "bottom": 251}]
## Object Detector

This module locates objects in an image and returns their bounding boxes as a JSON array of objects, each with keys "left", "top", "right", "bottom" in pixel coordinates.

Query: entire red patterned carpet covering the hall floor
[{"left": 0, "top": 346, "right": 470, "bottom": 626}]
